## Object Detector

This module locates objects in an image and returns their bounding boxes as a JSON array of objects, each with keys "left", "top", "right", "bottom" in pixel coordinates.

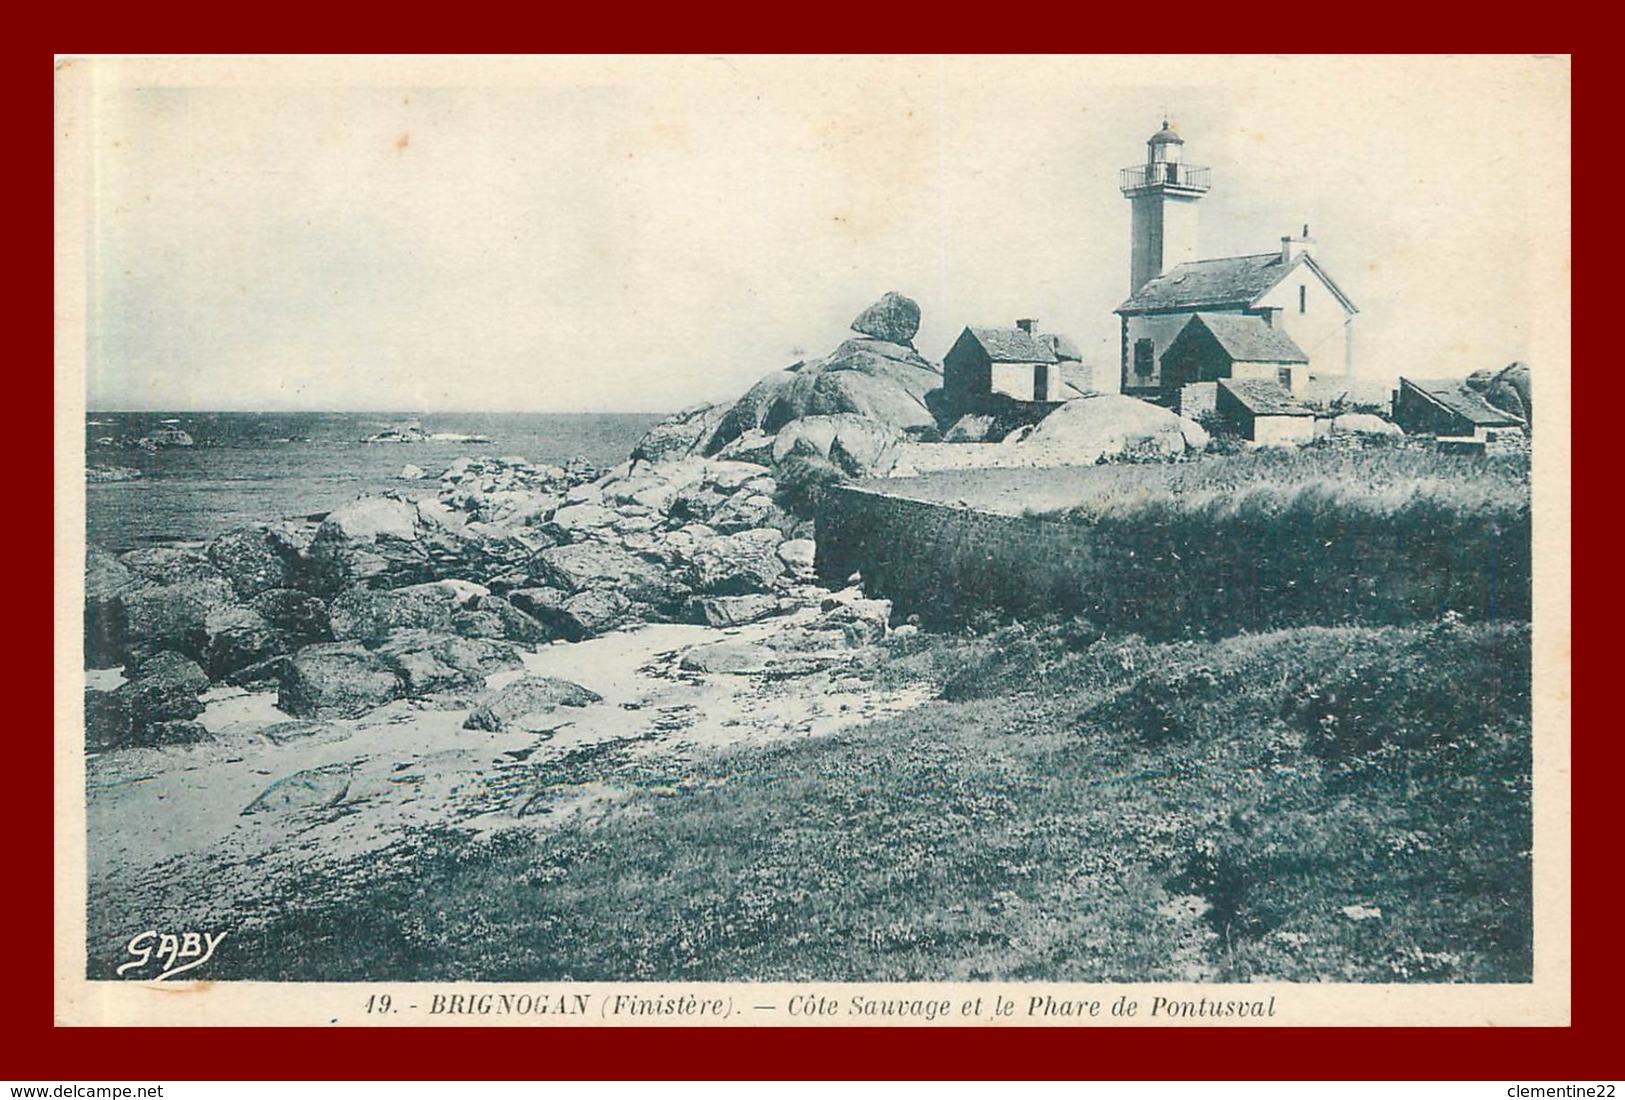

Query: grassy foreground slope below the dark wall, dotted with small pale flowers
[{"left": 231, "top": 616, "right": 1531, "bottom": 981}]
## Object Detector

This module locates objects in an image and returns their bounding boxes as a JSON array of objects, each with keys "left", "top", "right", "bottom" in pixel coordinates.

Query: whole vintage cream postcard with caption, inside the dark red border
[{"left": 55, "top": 55, "right": 1570, "bottom": 1027}]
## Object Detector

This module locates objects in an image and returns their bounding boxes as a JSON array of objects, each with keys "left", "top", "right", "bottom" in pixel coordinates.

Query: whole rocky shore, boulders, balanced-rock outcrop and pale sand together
[{"left": 85, "top": 285, "right": 1241, "bottom": 935}]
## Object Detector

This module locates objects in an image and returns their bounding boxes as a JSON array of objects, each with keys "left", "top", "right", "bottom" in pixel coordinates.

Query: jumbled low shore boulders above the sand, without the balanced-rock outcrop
[{"left": 85, "top": 441, "right": 887, "bottom": 749}]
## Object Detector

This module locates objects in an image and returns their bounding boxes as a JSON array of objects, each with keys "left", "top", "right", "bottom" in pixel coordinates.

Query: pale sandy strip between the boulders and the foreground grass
[{"left": 86, "top": 609, "right": 933, "bottom": 942}]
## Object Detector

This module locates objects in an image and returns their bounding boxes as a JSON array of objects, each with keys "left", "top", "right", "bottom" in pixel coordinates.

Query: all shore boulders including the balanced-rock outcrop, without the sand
[{"left": 85, "top": 292, "right": 1206, "bottom": 766}]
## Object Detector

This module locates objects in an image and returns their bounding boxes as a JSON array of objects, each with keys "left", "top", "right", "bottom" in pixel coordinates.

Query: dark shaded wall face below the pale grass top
[{"left": 817, "top": 486, "right": 1531, "bottom": 639}]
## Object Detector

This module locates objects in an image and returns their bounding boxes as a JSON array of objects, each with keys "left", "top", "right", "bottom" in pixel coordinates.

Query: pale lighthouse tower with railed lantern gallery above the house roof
[{"left": 1121, "top": 119, "right": 1211, "bottom": 294}]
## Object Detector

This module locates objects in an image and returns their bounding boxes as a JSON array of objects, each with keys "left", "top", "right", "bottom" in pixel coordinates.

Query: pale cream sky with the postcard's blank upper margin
[{"left": 59, "top": 57, "right": 1570, "bottom": 411}]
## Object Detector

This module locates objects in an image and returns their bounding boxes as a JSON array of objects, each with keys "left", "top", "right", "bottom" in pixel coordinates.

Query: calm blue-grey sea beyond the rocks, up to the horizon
[{"left": 85, "top": 413, "right": 661, "bottom": 551}]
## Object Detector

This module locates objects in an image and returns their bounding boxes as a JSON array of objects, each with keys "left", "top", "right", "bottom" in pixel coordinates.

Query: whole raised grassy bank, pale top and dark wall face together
[{"left": 817, "top": 440, "right": 1532, "bottom": 640}]
